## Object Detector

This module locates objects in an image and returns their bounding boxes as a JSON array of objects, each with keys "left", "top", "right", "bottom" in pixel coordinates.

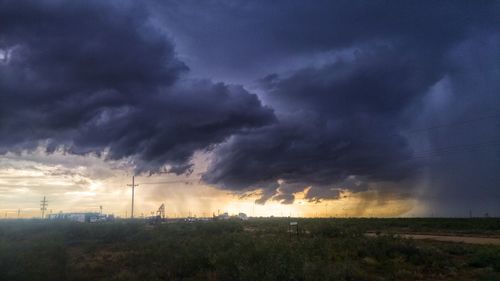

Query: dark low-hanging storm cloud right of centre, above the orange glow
[{"left": 204, "top": 48, "right": 426, "bottom": 199}]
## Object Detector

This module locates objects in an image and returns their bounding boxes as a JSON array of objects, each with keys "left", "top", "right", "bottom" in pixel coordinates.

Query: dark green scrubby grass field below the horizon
[{"left": 0, "top": 218, "right": 500, "bottom": 281}]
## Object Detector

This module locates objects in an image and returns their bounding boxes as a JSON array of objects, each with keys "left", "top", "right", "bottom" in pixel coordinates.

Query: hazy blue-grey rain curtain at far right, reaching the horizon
[{"left": 419, "top": 33, "right": 500, "bottom": 216}]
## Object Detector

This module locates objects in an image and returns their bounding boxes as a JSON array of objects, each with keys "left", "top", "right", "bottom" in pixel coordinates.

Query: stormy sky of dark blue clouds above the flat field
[{"left": 0, "top": 0, "right": 500, "bottom": 216}]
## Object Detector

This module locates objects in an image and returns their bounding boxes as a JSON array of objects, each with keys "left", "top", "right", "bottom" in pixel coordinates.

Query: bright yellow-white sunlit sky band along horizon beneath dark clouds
[{"left": 0, "top": 150, "right": 422, "bottom": 218}]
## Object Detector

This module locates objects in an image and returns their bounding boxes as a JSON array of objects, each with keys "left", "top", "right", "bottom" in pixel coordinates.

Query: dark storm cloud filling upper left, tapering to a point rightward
[{"left": 0, "top": 1, "right": 274, "bottom": 173}]
